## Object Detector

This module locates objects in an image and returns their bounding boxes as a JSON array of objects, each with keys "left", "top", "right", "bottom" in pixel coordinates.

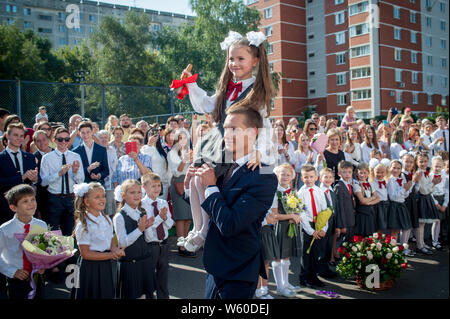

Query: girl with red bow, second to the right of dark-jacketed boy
[{"left": 370, "top": 163, "right": 389, "bottom": 233}]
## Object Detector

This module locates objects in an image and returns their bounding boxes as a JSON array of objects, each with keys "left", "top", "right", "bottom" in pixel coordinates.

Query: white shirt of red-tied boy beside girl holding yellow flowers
[{"left": 298, "top": 185, "right": 328, "bottom": 236}]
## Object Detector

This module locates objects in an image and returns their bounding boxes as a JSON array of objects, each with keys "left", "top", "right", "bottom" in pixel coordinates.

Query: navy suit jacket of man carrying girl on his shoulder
[{"left": 202, "top": 164, "right": 278, "bottom": 282}]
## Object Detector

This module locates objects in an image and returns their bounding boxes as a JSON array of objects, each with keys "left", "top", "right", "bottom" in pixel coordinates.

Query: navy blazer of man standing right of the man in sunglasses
[{"left": 73, "top": 142, "right": 109, "bottom": 185}]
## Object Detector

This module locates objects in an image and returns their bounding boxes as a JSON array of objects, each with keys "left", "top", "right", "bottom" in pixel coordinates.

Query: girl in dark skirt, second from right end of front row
[{"left": 416, "top": 153, "right": 442, "bottom": 255}]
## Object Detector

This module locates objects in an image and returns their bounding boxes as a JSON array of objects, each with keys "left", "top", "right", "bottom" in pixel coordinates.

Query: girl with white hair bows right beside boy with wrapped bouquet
[{"left": 74, "top": 182, "right": 125, "bottom": 299}]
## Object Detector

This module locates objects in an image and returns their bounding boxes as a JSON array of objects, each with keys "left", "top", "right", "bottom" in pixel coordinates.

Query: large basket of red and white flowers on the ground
[{"left": 336, "top": 233, "right": 408, "bottom": 289}]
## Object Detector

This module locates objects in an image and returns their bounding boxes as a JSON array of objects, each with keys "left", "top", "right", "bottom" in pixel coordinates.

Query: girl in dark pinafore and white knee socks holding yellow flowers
[{"left": 272, "top": 163, "right": 301, "bottom": 297}]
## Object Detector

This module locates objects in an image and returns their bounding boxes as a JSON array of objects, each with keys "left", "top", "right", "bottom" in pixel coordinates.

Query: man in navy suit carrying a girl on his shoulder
[{"left": 185, "top": 107, "right": 278, "bottom": 299}]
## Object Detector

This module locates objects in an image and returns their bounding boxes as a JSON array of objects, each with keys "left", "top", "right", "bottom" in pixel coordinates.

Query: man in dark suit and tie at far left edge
[{"left": 0, "top": 123, "right": 38, "bottom": 224}]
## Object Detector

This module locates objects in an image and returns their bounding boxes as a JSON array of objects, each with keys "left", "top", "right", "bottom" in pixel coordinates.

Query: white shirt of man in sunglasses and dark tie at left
[{"left": 40, "top": 149, "right": 84, "bottom": 194}]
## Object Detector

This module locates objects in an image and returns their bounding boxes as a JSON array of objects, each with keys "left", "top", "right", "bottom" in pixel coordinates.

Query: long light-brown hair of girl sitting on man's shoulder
[{"left": 211, "top": 37, "right": 274, "bottom": 123}]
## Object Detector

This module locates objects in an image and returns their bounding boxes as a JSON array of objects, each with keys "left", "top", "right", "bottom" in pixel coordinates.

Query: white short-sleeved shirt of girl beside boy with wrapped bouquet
[{"left": 75, "top": 212, "right": 114, "bottom": 252}]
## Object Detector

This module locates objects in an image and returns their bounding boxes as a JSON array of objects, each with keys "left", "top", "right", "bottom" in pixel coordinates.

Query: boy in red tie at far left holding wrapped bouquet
[{"left": 0, "top": 184, "right": 47, "bottom": 299}]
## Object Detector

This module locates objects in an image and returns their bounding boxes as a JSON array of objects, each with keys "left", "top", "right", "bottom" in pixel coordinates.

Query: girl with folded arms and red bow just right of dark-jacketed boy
[{"left": 353, "top": 164, "right": 380, "bottom": 236}]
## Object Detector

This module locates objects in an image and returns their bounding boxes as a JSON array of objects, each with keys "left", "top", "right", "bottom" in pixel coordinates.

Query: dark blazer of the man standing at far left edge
[{"left": 0, "top": 150, "right": 37, "bottom": 223}]
